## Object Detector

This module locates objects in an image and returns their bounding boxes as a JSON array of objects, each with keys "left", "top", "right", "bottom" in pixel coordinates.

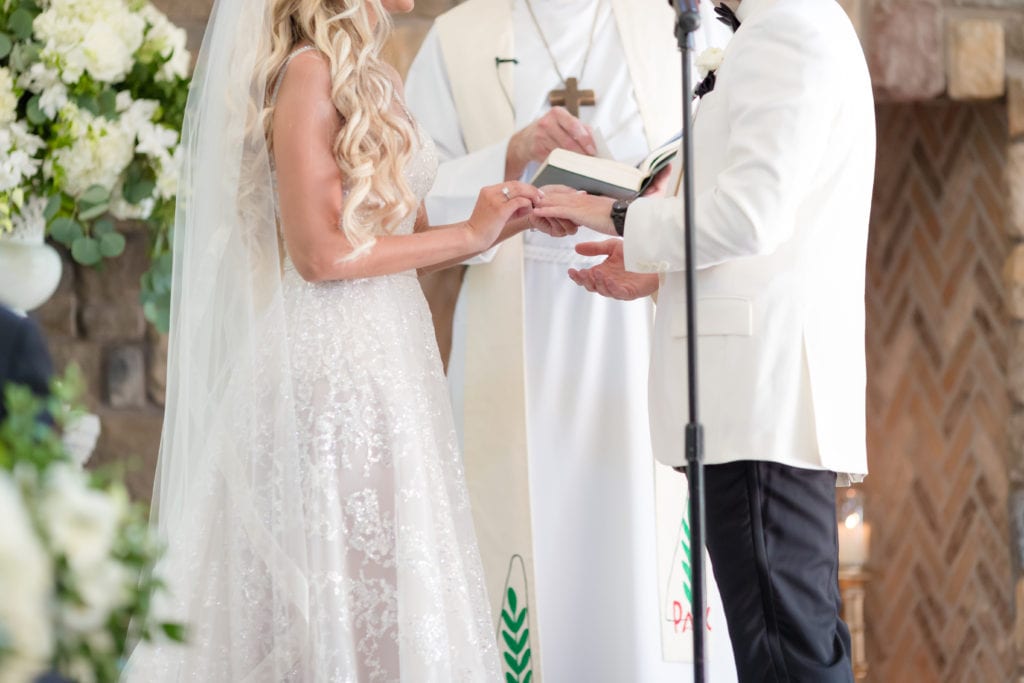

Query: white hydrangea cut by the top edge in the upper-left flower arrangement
[{"left": 33, "top": 0, "right": 145, "bottom": 84}]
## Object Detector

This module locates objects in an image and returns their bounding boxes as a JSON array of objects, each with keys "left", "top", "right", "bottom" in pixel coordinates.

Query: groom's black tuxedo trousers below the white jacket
[{"left": 705, "top": 461, "right": 853, "bottom": 683}]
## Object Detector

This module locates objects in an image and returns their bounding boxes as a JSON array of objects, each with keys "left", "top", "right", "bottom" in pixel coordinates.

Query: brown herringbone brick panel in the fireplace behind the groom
[{"left": 865, "top": 103, "right": 1015, "bottom": 683}]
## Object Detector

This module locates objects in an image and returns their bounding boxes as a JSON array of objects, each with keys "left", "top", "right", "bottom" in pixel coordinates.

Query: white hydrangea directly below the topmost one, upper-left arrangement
[{"left": 52, "top": 104, "right": 135, "bottom": 197}]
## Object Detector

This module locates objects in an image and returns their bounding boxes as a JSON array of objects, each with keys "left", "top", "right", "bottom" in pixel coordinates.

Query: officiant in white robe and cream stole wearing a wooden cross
[{"left": 406, "top": 0, "right": 731, "bottom": 683}]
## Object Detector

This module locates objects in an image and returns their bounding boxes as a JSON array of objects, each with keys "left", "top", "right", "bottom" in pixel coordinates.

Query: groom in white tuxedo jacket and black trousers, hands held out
[{"left": 538, "top": 0, "right": 874, "bottom": 683}]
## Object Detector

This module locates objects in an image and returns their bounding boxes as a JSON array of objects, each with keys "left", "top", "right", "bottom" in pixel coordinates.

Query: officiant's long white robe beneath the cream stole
[{"left": 406, "top": 0, "right": 734, "bottom": 683}]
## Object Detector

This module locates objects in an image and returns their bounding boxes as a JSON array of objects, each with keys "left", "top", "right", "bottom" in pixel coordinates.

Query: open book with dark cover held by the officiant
[{"left": 529, "top": 134, "right": 682, "bottom": 200}]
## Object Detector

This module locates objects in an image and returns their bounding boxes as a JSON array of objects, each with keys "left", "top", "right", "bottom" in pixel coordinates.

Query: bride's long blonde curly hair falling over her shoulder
[{"left": 257, "top": 0, "right": 417, "bottom": 255}]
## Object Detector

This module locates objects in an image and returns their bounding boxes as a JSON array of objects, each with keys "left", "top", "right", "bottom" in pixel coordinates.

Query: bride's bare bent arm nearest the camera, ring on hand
[{"left": 272, "top": 52, "right": 539, "bottom": 282}]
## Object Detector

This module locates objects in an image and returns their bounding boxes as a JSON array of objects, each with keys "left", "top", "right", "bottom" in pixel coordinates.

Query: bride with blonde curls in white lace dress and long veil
[{"left": 125, "top": 0, "right": 565, "bottom": 683}]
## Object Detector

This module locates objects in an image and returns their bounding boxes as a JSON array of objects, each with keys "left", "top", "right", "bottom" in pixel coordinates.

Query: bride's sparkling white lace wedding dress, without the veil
[{"left": 274, "top": 117, "right": 500, "bottom": 682}]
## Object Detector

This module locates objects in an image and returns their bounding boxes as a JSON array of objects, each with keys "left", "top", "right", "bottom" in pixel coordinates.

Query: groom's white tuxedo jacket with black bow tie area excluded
[{"left": 625, "top": 0, "right": 874, "bottom": 474}]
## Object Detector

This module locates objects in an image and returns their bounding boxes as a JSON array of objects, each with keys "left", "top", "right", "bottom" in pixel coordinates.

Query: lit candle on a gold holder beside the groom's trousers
[{"left": 836, "top": 486, "right": 871, "bottom": 681}]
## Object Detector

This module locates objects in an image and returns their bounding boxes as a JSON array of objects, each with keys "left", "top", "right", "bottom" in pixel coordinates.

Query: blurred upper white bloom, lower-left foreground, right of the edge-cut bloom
[{"left": 40, "top": 465, "right": 120, "bottom": 571}]
